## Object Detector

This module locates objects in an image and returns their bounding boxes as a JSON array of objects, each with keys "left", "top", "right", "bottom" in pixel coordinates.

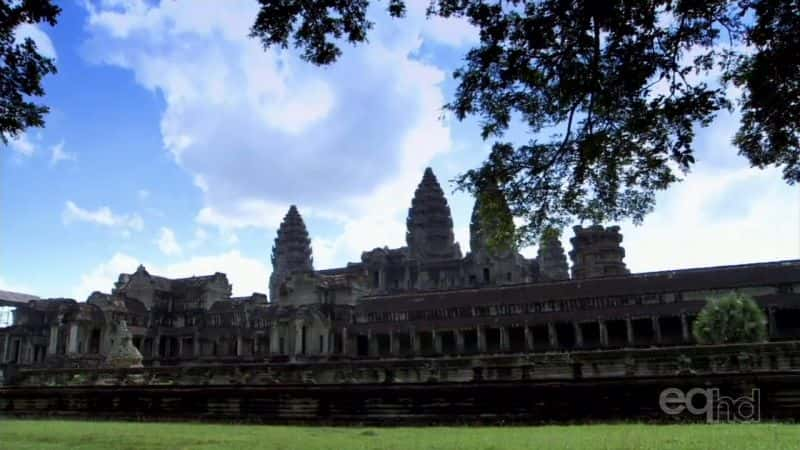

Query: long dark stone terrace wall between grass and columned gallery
[{"left": 0, "top": 342, "right": 800, "bottom": 424}]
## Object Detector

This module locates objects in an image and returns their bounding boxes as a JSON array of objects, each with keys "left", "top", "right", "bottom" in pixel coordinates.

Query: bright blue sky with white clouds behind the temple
[{"left": 0, "top": 0, "right": 800, "bottom": 300}]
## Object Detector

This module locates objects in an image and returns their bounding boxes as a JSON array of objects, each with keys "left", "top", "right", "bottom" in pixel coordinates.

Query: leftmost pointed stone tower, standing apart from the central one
[{"left": 269, "top": 205, "right": 314, "bottom": 301}]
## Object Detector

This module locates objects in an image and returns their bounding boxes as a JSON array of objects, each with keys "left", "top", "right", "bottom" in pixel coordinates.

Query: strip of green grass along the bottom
[{"left": 0, "top": 419, "right": 800, "bottom": 450}]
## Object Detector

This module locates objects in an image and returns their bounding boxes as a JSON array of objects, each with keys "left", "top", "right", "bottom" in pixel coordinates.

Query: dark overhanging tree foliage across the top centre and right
[{"left": 251, "top": 0, "right": 800, "bottom": 246}]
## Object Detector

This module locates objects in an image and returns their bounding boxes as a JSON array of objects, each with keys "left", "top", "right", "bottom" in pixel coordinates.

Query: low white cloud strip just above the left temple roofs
[{"left": 72, "top": 250, "right": 269, "bottom": 301}]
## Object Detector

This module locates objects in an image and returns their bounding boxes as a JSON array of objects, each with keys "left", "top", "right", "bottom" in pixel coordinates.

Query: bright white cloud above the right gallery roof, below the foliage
[{"left": 620, "top": 164, "right": 800, "bottom": 272}]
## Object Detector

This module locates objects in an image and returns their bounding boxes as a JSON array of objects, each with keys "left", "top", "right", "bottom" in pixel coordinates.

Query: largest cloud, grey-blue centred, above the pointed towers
[{"left": 82, "top": 1, "right": 456, "bottom": 229}]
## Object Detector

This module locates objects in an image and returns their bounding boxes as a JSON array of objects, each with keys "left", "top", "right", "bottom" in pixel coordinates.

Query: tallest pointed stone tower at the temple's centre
[{"left": 406, "top": 167, "right": 461, "bottom": 261}]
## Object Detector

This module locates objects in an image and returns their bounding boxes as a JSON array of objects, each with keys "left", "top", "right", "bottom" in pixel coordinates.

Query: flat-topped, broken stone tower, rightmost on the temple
[{"left": 569, "top": 225, "right": 630, "bottom": 279}]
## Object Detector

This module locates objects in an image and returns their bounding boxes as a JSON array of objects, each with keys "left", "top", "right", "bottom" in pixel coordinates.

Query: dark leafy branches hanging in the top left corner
[{"left": 0, "top": 0, "right": 61, "bottom": 143}]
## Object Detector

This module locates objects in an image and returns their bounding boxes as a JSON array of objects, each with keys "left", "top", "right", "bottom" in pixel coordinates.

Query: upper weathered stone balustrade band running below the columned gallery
[{"left": 5, "top": 341, "right": 800, "bottom": 387}]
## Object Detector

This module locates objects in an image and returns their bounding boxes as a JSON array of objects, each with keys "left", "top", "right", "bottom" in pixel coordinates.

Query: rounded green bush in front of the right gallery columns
[{"left": 692, "top": 292, "right": 767, "bottom": 344}]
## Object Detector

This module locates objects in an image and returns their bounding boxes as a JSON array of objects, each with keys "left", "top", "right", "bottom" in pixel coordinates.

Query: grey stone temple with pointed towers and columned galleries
[{"left": 0, "top": 169, "right": 800, "bottom": 368}]
